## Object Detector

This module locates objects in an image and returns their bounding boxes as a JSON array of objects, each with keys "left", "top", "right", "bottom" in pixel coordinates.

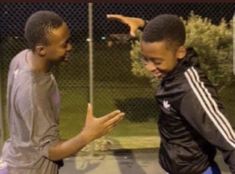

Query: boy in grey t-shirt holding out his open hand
[{"left": 0, "top": 11, "right": 124, "bottom": 174}]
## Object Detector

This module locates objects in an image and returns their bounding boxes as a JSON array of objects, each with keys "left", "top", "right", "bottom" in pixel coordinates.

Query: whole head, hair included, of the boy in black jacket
[{"left": 141, "top": 14, "right": 186, "bottom": 78}]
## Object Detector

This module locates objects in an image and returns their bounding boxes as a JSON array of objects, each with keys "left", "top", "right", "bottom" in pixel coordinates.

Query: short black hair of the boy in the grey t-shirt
[{"left": 24, "top": 11, "right": 64, "bottom": 50}]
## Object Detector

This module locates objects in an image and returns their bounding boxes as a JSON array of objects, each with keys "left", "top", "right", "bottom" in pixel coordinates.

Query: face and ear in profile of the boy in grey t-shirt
[{"left": 36, "top": 22, "right": 72, "bottom": 64}]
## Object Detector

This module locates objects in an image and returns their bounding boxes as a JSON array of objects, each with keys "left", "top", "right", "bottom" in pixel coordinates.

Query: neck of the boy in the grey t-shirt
[{"left": 26, "top": 51, "right": 52, "bottom": 73}]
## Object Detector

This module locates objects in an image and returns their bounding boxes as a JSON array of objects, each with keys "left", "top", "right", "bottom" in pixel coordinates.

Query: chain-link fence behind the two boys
[{"left": 0, "top": 3, "right": 235, "bottom": 148}]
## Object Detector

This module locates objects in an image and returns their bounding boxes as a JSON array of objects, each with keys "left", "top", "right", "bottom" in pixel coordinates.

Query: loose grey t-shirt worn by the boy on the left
[{"left": 2, "top": 50, "right": 60, "bottom": 174}]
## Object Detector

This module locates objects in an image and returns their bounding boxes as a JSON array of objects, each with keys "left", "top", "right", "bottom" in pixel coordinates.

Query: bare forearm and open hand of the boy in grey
[{"left": 48, "top": 104, "right": 124, "bottom": 161}]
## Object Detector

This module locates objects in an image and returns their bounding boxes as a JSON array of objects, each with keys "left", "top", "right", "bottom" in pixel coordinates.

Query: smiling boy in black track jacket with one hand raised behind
[{"left": 107, "top": 14, "right": 235, "bottom": 174}]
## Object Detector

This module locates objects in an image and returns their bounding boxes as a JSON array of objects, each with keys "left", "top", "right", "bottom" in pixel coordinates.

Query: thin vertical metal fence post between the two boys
[{"left": 88, "top": 3, "right": 95, "bottom": 156}]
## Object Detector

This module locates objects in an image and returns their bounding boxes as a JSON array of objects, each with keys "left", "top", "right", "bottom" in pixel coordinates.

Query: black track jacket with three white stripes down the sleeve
[{"left": 156, "top": 48, "right": 235, "bottom": 174}]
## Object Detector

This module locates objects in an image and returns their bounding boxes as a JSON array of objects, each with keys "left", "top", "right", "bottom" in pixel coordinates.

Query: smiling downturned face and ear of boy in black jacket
[{"left": 141, "top": 41, "right": 186, "bottom": 78}]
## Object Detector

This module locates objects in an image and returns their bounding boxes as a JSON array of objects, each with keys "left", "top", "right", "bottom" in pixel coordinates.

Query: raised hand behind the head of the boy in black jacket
[{"left": 107, "top": 14, "right": 145, "bottom": 37}]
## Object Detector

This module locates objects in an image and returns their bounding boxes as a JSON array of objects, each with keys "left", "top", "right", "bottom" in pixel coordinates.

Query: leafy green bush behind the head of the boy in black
[{"left": 130, "top": 12, "right": 233, "bottom": 88}]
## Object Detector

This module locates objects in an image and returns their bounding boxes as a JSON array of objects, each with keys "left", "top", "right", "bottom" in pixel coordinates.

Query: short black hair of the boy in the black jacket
[{"left": 142, "top": 14, "right": 186, "bottom": 49}]
